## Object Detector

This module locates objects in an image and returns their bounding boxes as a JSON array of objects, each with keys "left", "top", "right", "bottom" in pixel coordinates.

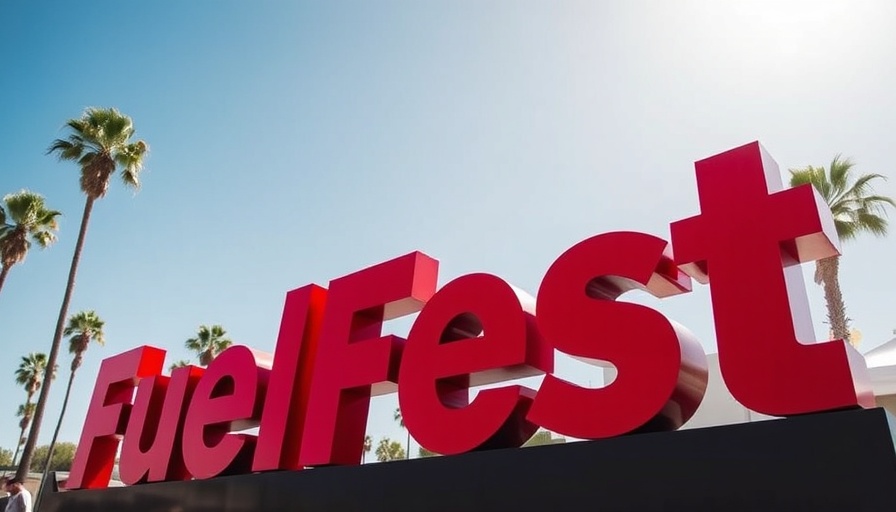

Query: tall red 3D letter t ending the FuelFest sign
[{"left": 672, "top": 142, "right": 874, "bottom": 416}]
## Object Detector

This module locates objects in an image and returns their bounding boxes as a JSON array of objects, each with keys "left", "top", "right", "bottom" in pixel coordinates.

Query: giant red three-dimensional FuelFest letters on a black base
[{"left": 67, "top": 142, "right": 874, "bottom": 489}]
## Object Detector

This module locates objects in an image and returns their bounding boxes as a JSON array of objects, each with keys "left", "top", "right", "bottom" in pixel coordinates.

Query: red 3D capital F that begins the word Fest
[{"left": 299, "top": 252, "right": 438, "bottom": 466}]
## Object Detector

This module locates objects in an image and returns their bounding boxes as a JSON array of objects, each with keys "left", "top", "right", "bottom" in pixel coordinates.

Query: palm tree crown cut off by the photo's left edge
[{"left": 0, "top": 190, "right": 61, "bottom": 296}]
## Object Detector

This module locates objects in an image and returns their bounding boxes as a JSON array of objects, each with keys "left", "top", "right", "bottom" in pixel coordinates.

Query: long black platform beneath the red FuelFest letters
[{"left": 39, "top": 409, "right": 896, "bottom": 512}]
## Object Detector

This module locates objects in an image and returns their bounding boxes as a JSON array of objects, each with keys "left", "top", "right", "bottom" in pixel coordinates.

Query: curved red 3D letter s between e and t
[{"left": 529, "top": 232, "right": 707, "bottom": 439}]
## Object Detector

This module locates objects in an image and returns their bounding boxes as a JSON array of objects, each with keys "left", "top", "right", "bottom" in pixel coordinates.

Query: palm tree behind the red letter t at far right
[{"left": 790, "top": 155, "right": 896, "bottom": 341}]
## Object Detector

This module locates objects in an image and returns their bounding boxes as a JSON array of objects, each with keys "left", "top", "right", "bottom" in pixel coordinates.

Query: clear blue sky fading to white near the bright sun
[{"left": 0, "top": 0, "right": 896, "bottom": 460}]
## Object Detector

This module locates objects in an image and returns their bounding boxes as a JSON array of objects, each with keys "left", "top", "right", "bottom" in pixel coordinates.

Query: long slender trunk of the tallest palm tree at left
[{"left": 16, "top": 196, "right": 94, "bottom": 480}]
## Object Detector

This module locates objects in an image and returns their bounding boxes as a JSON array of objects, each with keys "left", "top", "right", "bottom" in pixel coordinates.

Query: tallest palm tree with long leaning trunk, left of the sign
[{"left": 16, "top": 107, "right": 149, "bottom": 478}]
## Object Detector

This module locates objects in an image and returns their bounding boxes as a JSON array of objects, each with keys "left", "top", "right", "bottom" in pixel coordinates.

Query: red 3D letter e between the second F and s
[{"left": 398, "top": 274, "right": 554, "bottom": 454}]
